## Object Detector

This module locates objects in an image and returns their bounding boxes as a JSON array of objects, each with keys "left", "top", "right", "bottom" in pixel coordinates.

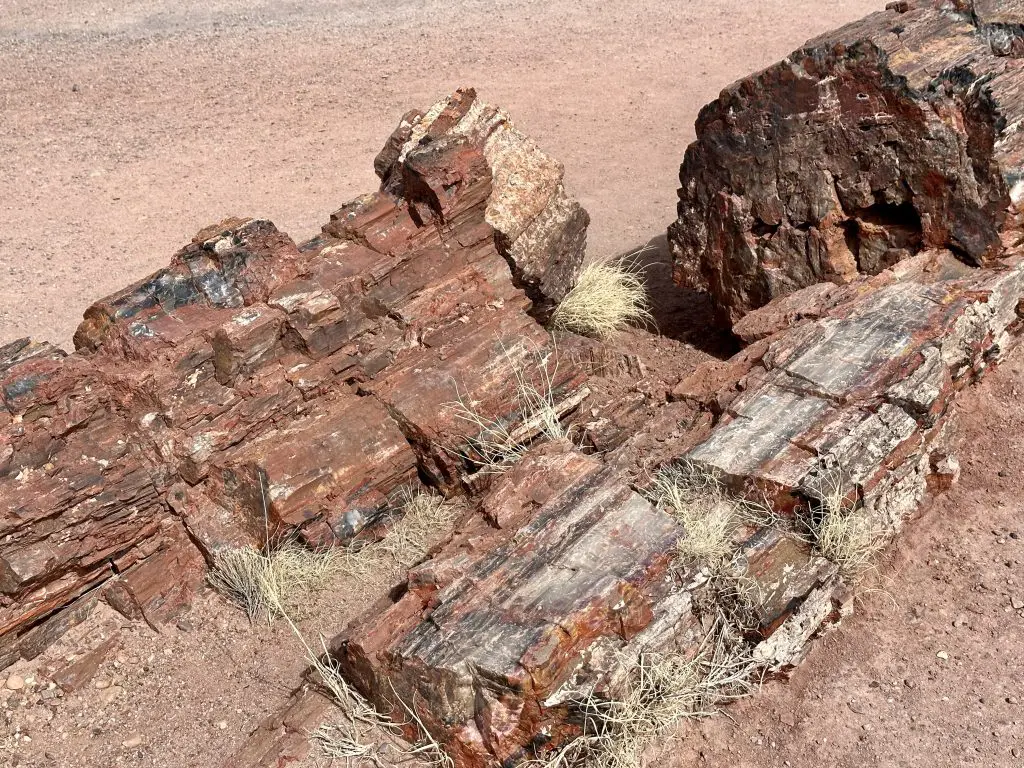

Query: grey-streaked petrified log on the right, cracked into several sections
[{"left": 334, "top": 244, "right": 1024, "bottom": 766}]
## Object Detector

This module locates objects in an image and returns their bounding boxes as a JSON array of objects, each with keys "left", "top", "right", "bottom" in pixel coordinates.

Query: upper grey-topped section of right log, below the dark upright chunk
[{"left": 689, "top": 249, "right": 1024, "bottom": 528}]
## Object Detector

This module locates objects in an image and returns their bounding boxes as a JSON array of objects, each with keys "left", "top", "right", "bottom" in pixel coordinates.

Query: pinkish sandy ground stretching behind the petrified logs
[{"left": 0, "top": 0, "right": 885, "bottom": 345}]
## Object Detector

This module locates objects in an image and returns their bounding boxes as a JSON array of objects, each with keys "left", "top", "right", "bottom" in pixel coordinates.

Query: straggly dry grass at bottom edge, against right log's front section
[{"left": 532, "top": 615, "right": 757, "bottom": 768}]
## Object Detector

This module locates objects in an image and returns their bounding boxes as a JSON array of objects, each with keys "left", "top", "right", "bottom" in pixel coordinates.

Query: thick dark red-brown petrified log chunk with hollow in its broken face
[{"left": 669, "top": 2, "right": 1024, "bottom": 323}]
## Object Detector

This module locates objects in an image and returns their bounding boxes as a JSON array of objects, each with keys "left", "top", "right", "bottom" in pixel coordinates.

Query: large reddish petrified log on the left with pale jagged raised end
[{"left": 0, "top": 88, "right": 586, "bottom": 663}]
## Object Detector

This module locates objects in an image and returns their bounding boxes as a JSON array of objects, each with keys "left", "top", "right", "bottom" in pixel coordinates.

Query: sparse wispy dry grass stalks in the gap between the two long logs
[{"left": 447, "top": 350, "right": 567, "bottom": 472}]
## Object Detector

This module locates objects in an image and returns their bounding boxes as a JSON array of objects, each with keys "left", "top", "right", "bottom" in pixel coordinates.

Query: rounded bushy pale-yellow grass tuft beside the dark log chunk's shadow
[{"left": 551, "top": 260, "right": 653, "bottom": 338}]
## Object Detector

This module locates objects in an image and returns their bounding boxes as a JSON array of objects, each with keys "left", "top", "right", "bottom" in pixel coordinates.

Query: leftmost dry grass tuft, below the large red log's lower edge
[{"left": 209, "top": 543, "right": 340, "bottom": 622}]
